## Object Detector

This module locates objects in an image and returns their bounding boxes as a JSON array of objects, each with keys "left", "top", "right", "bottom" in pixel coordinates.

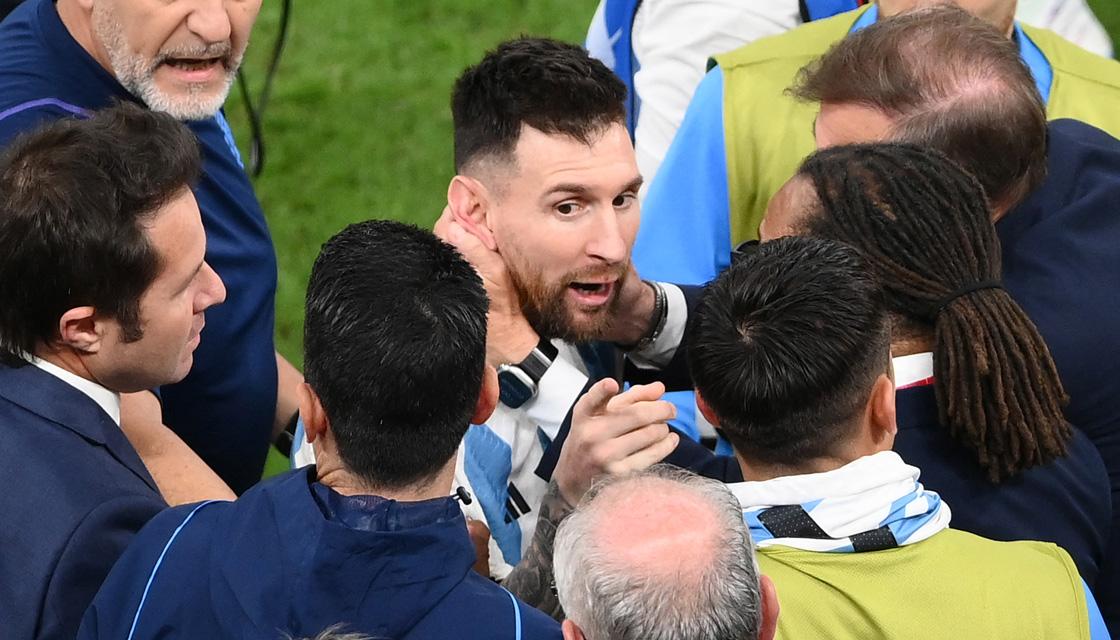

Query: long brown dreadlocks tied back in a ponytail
[{"left": 799, "top": 145, "right": 1072, "bottom": 482}]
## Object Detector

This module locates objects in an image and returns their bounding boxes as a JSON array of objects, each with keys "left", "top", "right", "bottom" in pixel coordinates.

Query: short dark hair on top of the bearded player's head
[{"left": 451, "top": 38, "right": 626, "bottom": 173}]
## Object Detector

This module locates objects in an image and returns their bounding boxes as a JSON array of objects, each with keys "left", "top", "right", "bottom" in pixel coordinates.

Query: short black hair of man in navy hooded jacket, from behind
[{"left": 304, "top": 221, "right": 487, "bottom": 489}]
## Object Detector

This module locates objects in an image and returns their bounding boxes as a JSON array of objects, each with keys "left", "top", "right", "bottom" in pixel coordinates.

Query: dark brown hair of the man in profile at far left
[{"left": 0, "top": 103, "right": 202, "bottom": 365}]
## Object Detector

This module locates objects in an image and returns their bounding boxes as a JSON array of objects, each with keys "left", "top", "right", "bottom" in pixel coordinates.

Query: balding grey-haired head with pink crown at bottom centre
[{"left": 553, "top": 465, "right": 763, "bottom": 640}]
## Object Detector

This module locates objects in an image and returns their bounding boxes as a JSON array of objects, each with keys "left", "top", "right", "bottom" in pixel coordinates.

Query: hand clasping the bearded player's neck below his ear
[{"left": 433, "top": 206, "right": 540, "bottom": 367}]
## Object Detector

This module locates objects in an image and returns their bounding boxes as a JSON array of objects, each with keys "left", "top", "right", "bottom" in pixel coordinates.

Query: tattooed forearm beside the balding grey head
[{"left": 502, "top": 480, "right": 572, "bottom": 620}]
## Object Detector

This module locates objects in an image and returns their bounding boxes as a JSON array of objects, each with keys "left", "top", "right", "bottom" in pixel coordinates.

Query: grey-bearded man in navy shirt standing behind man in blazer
[{"left": 0, "top": 0, "right": 301, "bottom": 495}]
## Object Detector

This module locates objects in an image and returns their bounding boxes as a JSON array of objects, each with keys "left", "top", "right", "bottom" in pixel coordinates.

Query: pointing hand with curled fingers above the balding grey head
[{"left": 553, "top": 378, "right": 680, "bottom": 504}]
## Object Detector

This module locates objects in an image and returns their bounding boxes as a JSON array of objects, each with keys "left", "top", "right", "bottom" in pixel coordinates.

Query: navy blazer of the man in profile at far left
[{"left": 0, "top": 365, "right": 167, "bottom": 640}]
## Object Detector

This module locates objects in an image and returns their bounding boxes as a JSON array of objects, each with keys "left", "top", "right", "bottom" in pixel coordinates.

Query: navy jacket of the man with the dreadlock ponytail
[{"left": 895, "top": 387, "right": 1112, "bottom": 586}]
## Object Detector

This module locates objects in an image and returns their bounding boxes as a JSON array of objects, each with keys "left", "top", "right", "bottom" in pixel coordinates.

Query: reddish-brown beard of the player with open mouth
[{"left": 508, "top": 261, "right": 627, "bottom": 344}]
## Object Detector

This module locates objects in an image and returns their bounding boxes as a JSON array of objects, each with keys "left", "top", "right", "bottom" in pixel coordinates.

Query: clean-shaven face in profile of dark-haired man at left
[{"left": 96, "top": 189, "right": 225, "bottom": 391}]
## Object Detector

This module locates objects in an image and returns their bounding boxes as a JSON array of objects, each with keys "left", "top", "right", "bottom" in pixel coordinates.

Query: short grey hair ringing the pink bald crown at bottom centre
[{"left": 553, "top": 465, "right": 762, "bottom": 640}]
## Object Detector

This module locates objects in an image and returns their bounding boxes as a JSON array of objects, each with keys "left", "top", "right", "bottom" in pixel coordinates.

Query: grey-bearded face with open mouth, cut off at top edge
[{"left": 91, "top": 0, "right": 261, "bottom": 120}]
